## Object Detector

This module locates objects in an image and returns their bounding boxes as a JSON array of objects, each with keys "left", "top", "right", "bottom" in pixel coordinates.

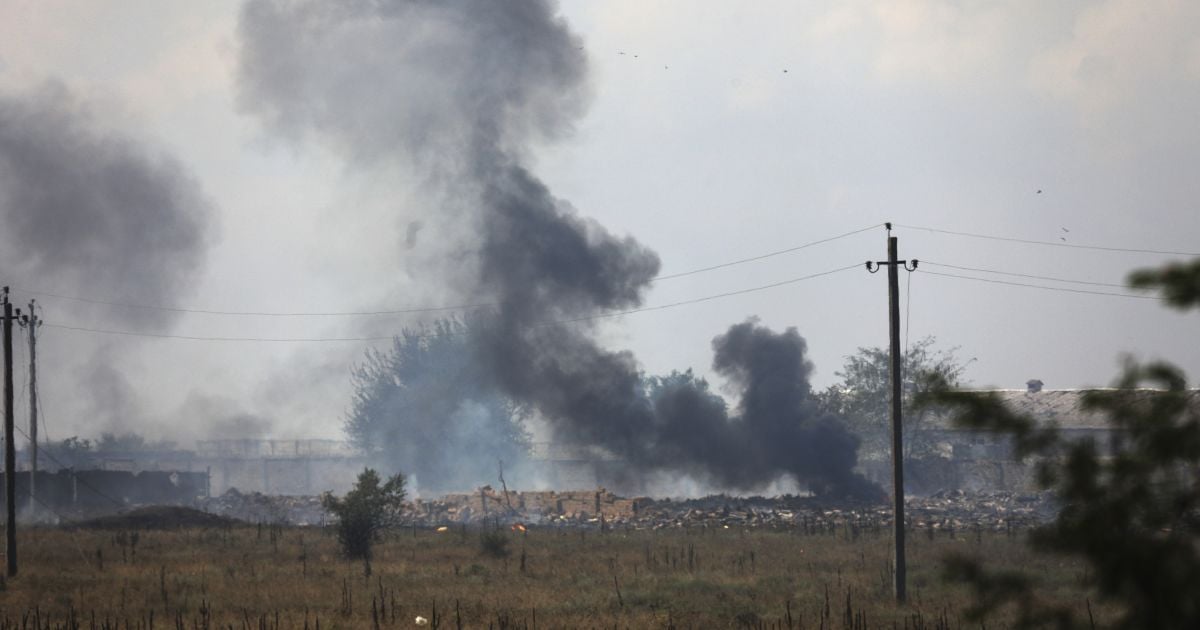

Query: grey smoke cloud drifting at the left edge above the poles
[{"left": 0, "top": 83, "right": 212, "bottom": 430}]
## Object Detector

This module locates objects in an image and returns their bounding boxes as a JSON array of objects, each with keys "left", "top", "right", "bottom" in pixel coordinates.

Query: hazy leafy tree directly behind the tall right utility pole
[{"left": 817, "top": 337, "right": 974, "bottom": 457}]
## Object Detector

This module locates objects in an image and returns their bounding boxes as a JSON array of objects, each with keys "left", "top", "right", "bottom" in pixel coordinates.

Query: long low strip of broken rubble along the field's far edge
[{"left": 192, "top": 486, "right": 1057, "bottom": 534}]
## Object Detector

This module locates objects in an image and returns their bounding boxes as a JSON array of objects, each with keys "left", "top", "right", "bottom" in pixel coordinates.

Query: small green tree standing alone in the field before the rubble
[{"left": 322, "top": 468, "right": 406, "bottom": 560}]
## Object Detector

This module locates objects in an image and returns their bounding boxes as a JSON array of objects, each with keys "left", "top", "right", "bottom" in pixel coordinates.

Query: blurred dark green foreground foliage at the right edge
[{"left": 919, "top": 264, "right": 1200, "bottom": 629}]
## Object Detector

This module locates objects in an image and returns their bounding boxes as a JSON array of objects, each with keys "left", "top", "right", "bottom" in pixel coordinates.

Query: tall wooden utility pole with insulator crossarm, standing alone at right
[{"left": 866, "top": 222, "right": 918, "bottom": 604}]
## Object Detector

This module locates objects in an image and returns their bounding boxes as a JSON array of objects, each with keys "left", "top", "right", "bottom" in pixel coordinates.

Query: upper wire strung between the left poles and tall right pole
[{"left": 13, "top": 223, "right": 883, "bottom": 319}]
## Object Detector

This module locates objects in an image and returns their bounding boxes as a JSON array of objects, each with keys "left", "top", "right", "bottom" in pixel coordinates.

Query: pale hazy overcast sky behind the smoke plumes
[{"left": 0, "top": 0, "right": 1200, "bottom": 438}]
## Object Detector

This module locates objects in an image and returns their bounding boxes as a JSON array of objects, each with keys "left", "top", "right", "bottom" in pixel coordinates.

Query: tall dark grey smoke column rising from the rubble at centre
[{"left": 240, "top": 0, "right": 870, "bottom": 493}]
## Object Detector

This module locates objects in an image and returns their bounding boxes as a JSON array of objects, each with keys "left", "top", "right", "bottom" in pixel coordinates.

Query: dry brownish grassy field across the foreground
[{"left": 0, "top": 518, "right": 1111, "bottom": 629}]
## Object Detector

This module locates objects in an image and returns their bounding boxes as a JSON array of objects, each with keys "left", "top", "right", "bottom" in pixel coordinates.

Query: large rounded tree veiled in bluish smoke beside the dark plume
[{"left": 344, "top": 319, "right": 529, "bottom": 491}]
